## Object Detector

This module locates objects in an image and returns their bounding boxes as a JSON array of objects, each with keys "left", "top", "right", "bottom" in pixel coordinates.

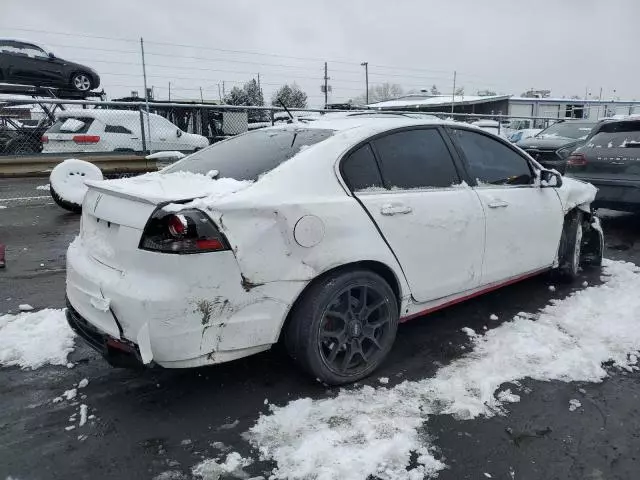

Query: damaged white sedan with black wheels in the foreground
[{"left": 62, "top": 116, "right": 603, "bottom": 384}]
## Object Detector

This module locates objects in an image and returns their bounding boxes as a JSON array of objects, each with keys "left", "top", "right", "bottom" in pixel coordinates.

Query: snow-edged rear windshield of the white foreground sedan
[{"left": 163, "top": 128, "right": 334, "bottom": 180}]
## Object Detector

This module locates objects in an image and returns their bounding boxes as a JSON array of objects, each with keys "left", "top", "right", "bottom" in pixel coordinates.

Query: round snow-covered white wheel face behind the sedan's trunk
[{"left": 49, "top": 158, "right": 103, "bottom": 205}]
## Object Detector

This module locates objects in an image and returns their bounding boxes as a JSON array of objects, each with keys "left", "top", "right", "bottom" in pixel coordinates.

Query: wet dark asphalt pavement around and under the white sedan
[{"left": 0, "top": 179, "right": 640, "bottom": 480}]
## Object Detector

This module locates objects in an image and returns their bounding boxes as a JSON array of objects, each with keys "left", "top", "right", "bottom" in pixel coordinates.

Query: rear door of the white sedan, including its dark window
[{"left": 342, "top": 128, "right": 484, "bottom": 302}]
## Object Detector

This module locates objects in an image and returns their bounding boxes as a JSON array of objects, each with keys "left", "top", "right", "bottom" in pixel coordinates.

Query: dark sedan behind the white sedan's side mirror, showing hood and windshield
[{"left": 518, "top": 120, "right": 598, "bottom": 173}]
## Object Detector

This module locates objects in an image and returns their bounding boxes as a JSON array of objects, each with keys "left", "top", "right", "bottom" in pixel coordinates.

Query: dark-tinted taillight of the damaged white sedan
[{"left": 139, "top": 209, "right": 229, "bottom": 254}]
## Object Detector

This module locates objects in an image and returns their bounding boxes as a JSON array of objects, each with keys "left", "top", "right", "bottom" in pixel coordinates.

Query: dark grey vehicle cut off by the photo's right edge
[{"left": 567, "top": 118, "right": 640, "bottom": 212}]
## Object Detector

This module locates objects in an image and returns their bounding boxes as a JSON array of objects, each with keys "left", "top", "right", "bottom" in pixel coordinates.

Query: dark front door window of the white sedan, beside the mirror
[{"left": 451, "top": 129, "right": 533, "bottom": 185}]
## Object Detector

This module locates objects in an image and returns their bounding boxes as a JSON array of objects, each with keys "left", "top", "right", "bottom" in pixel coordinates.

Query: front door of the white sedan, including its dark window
[{"left": 449, "top": 128, "right": 564, "bottom": 285}]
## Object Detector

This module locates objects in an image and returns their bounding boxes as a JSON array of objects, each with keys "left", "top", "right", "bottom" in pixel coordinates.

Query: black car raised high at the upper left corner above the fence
[{"left": 0, "top": 39, "right": 100, "bottom": 93}]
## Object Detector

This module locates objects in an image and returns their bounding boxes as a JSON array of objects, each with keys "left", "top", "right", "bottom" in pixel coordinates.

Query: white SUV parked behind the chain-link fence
[{"left": 42, "top": 109, "right": 209, "bottom": 153}]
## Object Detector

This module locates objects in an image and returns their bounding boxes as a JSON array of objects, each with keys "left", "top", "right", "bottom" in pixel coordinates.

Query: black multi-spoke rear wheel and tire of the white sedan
[{"left": 284, "top": 270, "right": 399, "bottom": 385}]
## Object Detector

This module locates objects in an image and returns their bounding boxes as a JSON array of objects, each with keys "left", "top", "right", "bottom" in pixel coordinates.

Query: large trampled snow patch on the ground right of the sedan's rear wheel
[{"left": 248, "top": 260, "right": 640, "bottom": 480}]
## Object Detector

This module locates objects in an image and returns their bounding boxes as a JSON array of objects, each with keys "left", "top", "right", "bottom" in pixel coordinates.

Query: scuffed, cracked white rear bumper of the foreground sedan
[{"left": 67, "top": 239, "right": 304, "bottom": 368}]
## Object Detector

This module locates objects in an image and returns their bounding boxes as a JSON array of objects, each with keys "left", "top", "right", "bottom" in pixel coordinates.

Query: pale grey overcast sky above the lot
[{"left": 0, "top": 0, "right": 640, "bottom": 106}]
